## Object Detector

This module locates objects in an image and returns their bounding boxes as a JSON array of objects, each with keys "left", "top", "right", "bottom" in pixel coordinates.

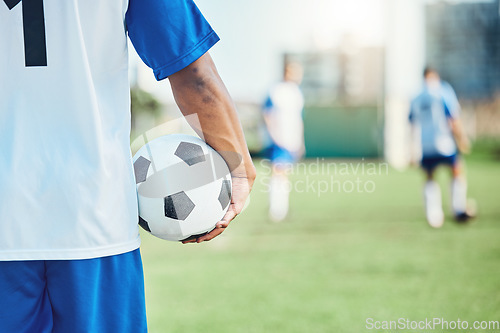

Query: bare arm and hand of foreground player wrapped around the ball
[{"left": 169, "top": 53, "right": 256, "bottom": 243}]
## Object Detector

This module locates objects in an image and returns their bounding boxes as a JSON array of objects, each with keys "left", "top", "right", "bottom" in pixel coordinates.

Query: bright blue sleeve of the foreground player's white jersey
[{"left": 125, "top": 0, "right": 219, "bottom": 80}]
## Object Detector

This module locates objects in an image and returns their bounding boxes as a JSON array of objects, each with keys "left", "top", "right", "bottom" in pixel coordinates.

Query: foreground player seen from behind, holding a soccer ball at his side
[{"left": 0, "top": 0, "right": 255, "bottom": 333}]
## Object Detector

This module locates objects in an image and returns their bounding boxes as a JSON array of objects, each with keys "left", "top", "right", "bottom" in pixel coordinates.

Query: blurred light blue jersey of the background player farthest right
[{"left": 409, "top": 82, "right": 460, "bottom": 159}]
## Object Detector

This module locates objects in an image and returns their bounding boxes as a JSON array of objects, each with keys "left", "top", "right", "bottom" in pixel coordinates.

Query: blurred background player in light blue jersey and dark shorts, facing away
[{"left": 409, "top": 67, "right": 473, "bottom": 228}]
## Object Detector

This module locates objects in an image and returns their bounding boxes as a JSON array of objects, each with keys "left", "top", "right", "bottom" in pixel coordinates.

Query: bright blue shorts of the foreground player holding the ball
[{"left": 0, "top": 249, "right": 147, "bottom": 333}]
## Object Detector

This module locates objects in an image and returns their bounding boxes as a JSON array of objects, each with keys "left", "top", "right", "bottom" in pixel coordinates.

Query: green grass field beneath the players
[{"left": 142, "top": 146, "right": 500, "bottom": 333}]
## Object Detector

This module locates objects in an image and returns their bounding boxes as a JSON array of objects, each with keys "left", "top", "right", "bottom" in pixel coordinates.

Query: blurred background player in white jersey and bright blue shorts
[{"left": 263, "top": 63, "right": 304, "bottom": 222}]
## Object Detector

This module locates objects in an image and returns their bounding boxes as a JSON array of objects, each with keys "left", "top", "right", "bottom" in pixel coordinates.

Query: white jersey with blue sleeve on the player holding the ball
[{"left": 0, "top": 0, "right": 218, "bottom": 260}]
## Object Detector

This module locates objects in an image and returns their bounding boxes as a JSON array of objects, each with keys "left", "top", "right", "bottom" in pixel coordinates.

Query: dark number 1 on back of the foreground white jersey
[{"left": 3, "top": 0, "right": 47, "bottom": 67}]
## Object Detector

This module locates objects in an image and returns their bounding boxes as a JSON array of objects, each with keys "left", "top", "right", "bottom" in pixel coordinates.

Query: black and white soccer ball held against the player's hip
[{"left": 133, "top": 134, "right": 232, "bottom": 241}]
